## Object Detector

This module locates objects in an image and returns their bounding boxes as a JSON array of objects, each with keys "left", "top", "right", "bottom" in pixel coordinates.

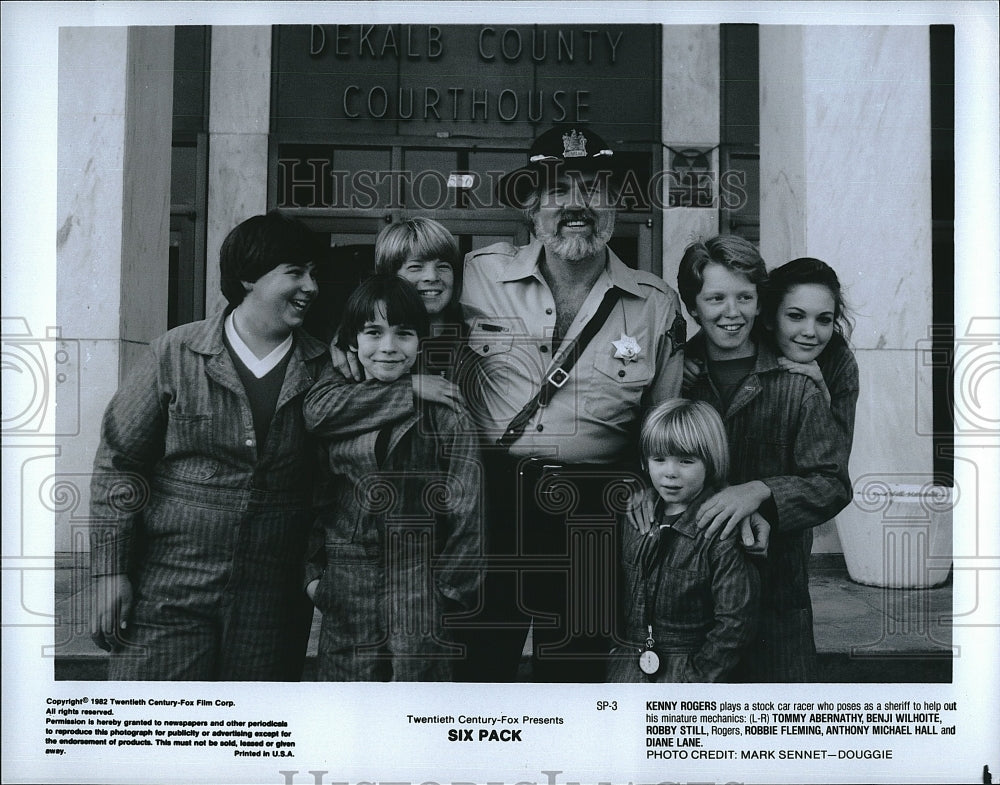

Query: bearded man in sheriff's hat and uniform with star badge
[{"left": 459, "top": 127, "right": 685, "bottom": 682}]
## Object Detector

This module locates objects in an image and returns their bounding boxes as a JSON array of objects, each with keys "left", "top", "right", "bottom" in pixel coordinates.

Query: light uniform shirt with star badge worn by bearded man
[{"left": 461, "top": 239, "right": 684, "bottom": 463}]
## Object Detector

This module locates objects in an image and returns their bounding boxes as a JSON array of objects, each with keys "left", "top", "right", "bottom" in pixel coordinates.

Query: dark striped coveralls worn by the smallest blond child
[{"left": 609, "top": 488, "right": 759, "bottom": 682}]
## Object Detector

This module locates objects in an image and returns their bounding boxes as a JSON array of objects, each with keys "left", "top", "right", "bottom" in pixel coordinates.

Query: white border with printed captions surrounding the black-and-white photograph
[{"left": 2, "top": 0, "right": 1000, "bottom": 785}]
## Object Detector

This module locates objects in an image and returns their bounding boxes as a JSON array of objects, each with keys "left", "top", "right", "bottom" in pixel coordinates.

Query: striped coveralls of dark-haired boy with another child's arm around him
[{"left": 304, "top": 392, "right": 483, "bottom": 681}]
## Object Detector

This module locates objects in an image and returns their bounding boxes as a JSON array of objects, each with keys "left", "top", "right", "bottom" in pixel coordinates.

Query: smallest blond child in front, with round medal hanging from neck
[{"left": 608, "top": 398, "right": 759, "bottom": 682}]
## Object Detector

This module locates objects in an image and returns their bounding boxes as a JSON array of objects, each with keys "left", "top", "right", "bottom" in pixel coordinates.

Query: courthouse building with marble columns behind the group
[{"left": 56, "top": 24, "right": 958, "bottom": 600}]
